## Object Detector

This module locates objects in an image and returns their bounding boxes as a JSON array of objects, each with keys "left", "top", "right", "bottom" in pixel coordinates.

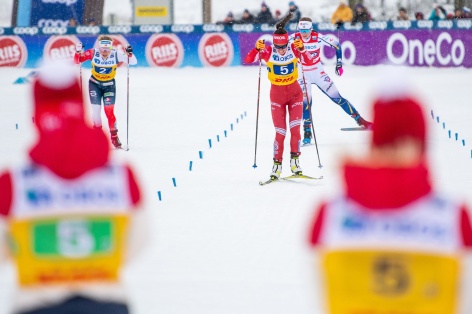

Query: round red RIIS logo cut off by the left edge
[{"left": 0, "top": 36, "right": 28, "bottom": 68}]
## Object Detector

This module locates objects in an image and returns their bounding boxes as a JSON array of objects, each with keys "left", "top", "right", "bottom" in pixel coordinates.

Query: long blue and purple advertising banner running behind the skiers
[{"left": 0, "top": 21, "right": 472, "bottom": 68}]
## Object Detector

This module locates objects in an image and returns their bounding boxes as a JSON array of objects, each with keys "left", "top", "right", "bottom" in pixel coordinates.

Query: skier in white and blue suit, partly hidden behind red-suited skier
[{"left": 289, "top": 17, "right": 372, "bottom": 144}]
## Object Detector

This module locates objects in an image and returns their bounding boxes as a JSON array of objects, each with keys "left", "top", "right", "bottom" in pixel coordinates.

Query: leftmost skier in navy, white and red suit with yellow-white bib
[{"left": 74, "top": 36, "right": 138, "bottom": 148}]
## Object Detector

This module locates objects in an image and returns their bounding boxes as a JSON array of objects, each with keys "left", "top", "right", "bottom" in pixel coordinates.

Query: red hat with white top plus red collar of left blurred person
[{"left": 29, "top": 60, "right": 109, "bottom": 179}]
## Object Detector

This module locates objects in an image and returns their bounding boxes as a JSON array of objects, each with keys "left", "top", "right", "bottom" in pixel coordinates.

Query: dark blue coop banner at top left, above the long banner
[{"left": 30, "top": 0, "right": 85, "bottom": 27}]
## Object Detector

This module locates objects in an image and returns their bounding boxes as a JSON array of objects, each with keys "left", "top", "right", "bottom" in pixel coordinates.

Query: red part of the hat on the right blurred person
[{"left": 372, "top": 95, "right": 426, "bottom": 151}]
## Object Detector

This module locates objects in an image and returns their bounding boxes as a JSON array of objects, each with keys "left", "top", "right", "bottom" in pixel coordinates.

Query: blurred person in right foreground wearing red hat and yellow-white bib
[{"left": 310, "top": 70, "right": 472, "bottom": 314}]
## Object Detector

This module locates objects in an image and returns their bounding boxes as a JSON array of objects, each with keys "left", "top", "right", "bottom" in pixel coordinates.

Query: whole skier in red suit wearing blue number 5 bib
[{"left": 245, "top": 13, "right": 311, "bottom": 180}]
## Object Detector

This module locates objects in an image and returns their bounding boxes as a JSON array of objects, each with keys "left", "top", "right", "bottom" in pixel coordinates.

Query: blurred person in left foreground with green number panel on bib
[{"left": 0, "top": 61, "right": 146, "bottom": 314}]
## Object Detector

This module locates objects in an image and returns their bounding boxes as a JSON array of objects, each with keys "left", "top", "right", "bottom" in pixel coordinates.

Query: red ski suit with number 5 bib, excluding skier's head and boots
[{"left": 244, "top": 44, "right": 311, "bottom": 161}]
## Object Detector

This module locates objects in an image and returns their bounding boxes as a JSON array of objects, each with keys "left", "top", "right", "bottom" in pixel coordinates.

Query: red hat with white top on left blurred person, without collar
[{"left": 33, "top": 61, "right": 84, "bottom": 132}]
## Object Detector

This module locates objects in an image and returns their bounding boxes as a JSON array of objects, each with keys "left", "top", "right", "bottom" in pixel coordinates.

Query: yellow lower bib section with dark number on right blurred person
[{"left": 322, "top": 250, "right": 459, "bottom": 314}]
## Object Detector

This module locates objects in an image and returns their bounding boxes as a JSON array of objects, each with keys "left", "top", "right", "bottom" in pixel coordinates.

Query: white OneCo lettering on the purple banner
[{"left": 387, "top": 32, "right": 465, "bottom": 66}]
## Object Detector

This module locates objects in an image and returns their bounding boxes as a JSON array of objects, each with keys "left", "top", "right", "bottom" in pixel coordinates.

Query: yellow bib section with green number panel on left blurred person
[{"left": 10, "top": 215, "right": 128, "bottom": 286}]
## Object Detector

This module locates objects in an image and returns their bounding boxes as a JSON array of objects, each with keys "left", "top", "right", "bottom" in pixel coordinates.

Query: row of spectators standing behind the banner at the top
[{"left": 217, "top": 0, "right": 472, "bottom": 28}]
